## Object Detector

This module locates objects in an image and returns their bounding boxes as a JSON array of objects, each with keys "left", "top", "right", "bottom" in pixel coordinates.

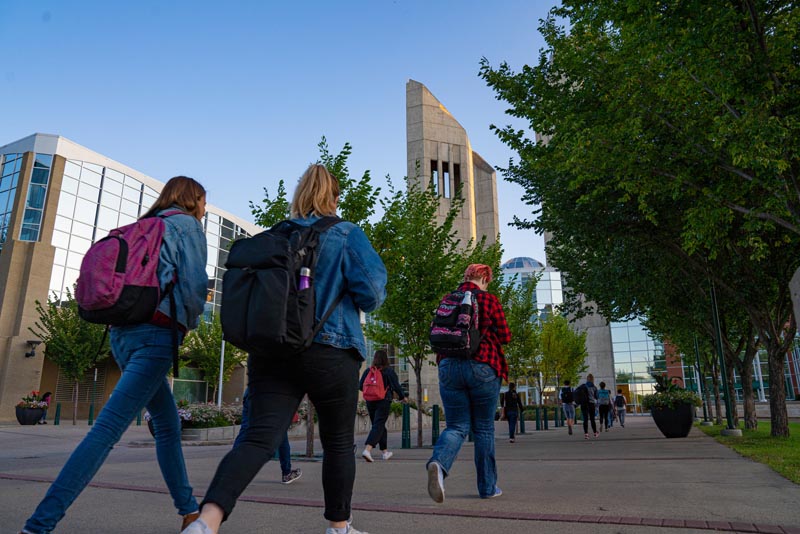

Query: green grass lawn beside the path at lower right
[{"left": 695, "top": 421, "right": 800, "bottom": 484}]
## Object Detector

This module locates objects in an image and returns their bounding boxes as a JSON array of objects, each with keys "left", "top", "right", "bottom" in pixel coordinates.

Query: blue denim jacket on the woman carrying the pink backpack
[{"left": 158, "top": 206, "right": 208, "bottom": 330}]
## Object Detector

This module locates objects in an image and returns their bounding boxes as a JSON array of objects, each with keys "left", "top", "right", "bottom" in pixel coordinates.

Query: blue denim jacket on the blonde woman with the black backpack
[{"left": 292, "top": 216, "right": 386, "bottom": 358}]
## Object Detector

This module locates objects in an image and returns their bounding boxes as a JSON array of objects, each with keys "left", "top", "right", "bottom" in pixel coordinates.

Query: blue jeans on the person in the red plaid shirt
[{"left": 428, "top": 358, "right": 500, "bottom": 498}]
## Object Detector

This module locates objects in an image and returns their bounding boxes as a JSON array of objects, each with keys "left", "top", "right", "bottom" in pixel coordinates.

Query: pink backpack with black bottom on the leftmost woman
[{"left": 75, "top": 210, "right": 183, "bottom": 326}]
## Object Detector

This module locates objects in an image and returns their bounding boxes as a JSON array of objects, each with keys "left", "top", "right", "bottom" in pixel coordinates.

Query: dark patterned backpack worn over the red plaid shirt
[{"left": 429, "top": 290, "right": 481, "bottom": 358}]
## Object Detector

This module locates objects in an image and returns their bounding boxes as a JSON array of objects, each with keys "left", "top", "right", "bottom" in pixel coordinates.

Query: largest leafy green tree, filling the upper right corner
[{"left": 481, "top": 0, "right": 800, "bottom": 436}]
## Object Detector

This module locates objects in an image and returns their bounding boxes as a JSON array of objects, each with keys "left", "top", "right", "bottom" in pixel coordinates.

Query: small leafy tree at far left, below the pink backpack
[{"left": 29, "top": 289, "right": 111, "bottom": 425}]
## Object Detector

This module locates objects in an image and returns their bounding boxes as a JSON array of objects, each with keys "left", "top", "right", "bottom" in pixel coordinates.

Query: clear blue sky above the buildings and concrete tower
[{"left": 0, "top": 0, "right": 557, "bottom": 261}]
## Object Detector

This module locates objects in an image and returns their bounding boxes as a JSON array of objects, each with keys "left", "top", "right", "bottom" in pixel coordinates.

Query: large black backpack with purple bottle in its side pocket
[{"left": 220, "top": 217, "right": 343, "bottom": 356}]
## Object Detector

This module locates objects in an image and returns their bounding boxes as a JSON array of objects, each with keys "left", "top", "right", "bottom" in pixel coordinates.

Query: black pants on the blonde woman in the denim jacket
[{"left": 201, "top": 343, "right": 361, "bottom": 521}]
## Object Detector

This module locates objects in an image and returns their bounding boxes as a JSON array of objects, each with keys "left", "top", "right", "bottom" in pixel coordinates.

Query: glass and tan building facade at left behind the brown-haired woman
[{"left": 0, "top": 134, "right": 259, "bottom": 420}]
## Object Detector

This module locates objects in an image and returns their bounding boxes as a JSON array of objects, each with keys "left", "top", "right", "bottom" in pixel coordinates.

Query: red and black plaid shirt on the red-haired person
[{"left": 436, "top": 282, "right": 511, "bottom": 380}]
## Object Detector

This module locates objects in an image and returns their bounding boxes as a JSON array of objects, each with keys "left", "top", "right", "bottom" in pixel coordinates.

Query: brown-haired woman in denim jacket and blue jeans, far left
[{"left": 22, "top": 176, "right": 208, "bottom": 534}]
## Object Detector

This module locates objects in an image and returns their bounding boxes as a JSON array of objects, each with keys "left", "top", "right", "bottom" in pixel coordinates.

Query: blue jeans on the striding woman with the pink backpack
[{"left": 25, "top": 324, "right": 198, "bottom": 534}]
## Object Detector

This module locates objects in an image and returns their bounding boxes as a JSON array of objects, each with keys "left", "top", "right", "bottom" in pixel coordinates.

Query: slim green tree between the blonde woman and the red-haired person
[{"left": 367, "top": 181, "right": 501, "bottom": 447}]
